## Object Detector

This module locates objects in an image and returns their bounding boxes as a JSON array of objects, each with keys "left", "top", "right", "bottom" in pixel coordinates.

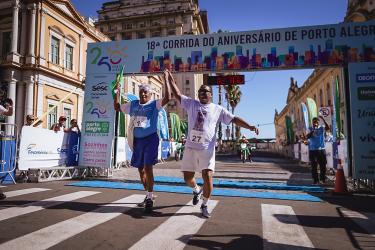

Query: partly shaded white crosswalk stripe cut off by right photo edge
[{"left": 339, "top": 208, "right": 375, "bottom": 237}]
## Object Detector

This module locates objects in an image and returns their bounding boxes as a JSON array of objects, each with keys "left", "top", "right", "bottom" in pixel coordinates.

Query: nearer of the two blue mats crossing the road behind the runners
[{"left": 67, "top": 181, "right": 322, "bottom": 202}]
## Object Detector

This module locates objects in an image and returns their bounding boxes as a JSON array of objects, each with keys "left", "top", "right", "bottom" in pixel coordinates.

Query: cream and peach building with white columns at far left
[{"left": 0, "top": 0, "right": 109, "bottom": 131}]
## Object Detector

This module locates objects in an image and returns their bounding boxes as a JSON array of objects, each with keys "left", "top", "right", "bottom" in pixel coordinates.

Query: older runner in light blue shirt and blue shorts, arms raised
[{"left": 114, "top": 70, "right": 171, "bottom": 213}]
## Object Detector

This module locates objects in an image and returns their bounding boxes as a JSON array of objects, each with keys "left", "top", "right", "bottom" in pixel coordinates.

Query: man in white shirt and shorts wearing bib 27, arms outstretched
[{"left": 166, "top": 71, "right": 259, "bottom": 218}]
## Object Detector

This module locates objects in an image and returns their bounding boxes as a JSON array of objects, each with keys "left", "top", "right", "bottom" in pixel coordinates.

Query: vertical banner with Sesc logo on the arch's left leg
[{"left": 79, "top": 74, "right": 115, "bottom": 168}]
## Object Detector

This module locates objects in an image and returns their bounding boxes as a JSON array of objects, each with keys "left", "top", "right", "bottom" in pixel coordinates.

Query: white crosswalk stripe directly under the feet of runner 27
[{"left": 129, "top": 200, "right": 218, "bottom": 250}]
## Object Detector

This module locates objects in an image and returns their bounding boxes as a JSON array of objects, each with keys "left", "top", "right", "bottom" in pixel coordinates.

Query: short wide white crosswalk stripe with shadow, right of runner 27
[{"left": 262, "top": 204, "right": 314, "bottom": 249}]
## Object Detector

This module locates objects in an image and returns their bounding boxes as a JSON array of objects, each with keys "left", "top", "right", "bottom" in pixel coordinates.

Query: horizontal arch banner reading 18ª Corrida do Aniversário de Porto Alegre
[{"left": 87, "top": 21, "right": 375, "bottom": 74}]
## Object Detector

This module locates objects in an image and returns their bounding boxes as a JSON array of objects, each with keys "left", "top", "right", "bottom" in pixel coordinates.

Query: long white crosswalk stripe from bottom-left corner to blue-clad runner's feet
[{"left": 0, "top": 195, "right": 145, "bottom": 250}]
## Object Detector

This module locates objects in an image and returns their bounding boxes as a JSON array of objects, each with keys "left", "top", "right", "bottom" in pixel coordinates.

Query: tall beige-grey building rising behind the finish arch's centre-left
[{"left": 95, "top": 0, "right": 209, "bottom": 118}]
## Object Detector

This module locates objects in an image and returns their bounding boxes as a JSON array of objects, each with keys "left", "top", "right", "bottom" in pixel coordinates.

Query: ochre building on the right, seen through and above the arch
[{"left": 274, "top": 0, "right": 375, "bottom": 146}]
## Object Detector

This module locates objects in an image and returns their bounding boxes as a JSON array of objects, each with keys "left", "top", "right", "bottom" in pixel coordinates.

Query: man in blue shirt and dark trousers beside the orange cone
[{"left": 306, "top": 116, "right": 330, "bottom": 184}]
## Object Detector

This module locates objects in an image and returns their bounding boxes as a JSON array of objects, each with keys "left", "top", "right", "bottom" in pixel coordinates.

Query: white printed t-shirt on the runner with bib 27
[{"left": 181, "top": 95, "right": 234, "bottom": 150}]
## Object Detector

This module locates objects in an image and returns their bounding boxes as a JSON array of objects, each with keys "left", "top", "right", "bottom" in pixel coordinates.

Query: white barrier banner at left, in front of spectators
[{"left": 18, "top": 126, "right": 68, "bottom": 171}]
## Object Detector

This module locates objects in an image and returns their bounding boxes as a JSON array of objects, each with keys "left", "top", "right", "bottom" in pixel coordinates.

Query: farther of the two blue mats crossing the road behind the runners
[{"left": 154, "top": 176, "right": 325, "bottom": 193}]
